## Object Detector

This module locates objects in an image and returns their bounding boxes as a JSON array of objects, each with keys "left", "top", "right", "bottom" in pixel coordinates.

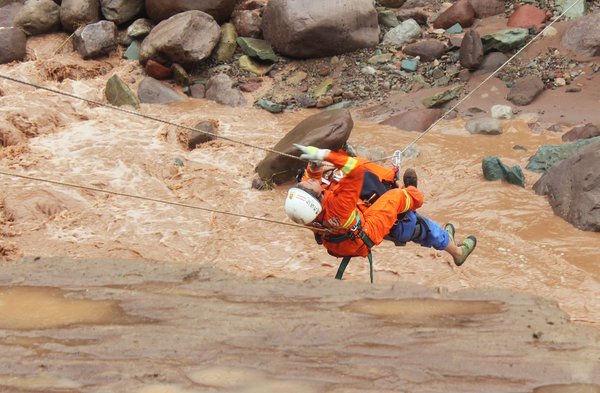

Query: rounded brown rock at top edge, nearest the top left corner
[{"left": 13, "top": 0, "right": 61, "bottom": 35}]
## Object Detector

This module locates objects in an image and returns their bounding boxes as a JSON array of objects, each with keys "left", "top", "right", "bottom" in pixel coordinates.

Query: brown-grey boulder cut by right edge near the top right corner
[{"left": 560, "top": 12, "right": 600, "bottom": 56}]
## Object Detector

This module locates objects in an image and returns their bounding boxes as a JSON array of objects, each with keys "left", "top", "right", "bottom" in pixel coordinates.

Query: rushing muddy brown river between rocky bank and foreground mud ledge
[{"left": 0, "top": 38, "right": 600, "bottom": 330}]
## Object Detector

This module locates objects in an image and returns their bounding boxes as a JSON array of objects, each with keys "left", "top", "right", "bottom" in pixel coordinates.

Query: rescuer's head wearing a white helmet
[{"left": 285, "top": 179, "right": 323, "bottom": 225}]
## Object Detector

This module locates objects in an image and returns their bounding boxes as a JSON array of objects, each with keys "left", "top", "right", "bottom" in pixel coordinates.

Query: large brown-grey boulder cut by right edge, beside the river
[{"left": 533, "top": 138, "right": 600, "bottom": 232}]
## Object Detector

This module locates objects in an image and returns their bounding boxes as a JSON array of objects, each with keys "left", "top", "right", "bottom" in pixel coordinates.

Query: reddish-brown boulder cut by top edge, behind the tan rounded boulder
[{"left": 146, "top": 0, "right": 237, "bottom": 23}]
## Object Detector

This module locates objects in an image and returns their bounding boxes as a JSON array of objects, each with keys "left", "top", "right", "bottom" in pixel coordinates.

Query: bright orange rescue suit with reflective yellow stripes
[{"left": 315, "top": 152, "right": 423, "bottom": 257}]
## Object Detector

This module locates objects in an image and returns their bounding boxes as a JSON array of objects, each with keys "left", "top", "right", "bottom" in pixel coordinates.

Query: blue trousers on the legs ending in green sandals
[{"left": 389, "top": 211, "right": 450, "bottom": 250}]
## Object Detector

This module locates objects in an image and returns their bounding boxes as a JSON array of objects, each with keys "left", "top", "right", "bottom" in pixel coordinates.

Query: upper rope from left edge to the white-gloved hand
[{"left": 0, "top": 74, "right": 305, "bottom": 161}]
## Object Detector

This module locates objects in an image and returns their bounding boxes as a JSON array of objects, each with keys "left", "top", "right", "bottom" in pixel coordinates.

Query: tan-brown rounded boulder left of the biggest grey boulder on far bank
[{"left": 140, "top": 11, "right": 221, "bottom": 64}]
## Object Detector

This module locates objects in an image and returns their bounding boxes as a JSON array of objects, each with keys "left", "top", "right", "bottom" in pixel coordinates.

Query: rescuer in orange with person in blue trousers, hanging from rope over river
[{"left": 285, "top": 145, "right": 477, "bottom": 279}]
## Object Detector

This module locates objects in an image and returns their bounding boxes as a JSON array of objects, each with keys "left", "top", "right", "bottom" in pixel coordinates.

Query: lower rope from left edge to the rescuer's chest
[{"left": 0, "top": 170, "right": 326, "bottom": 232}]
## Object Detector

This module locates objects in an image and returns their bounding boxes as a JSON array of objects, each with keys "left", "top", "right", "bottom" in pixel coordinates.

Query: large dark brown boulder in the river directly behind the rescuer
[{"left": 255, "top": 109, "right": 354, "bottom": 184}]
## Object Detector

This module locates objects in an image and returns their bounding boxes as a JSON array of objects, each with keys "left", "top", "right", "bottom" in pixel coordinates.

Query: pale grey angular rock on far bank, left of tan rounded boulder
[{"left": 73, "top": 20, "right": 117, "bottom": 59}]
